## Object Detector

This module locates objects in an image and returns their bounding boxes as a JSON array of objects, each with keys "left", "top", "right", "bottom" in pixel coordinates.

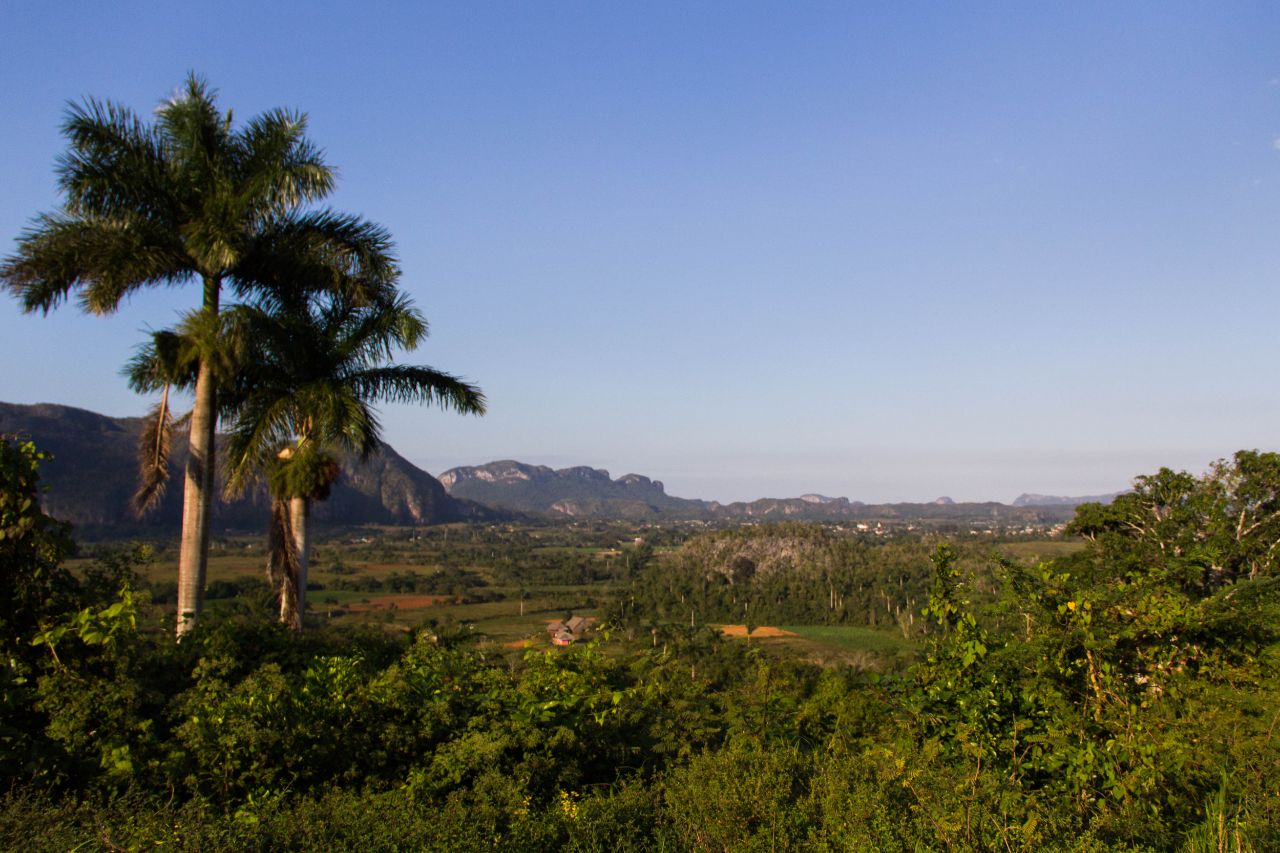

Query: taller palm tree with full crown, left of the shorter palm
[{"left": 0, "top": 74, "right": 398, "bottom": 638}]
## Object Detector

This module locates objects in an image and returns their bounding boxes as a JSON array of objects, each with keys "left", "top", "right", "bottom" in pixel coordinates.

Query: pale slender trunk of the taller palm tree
[{"left": 178, "top": 277, "right": 221, "bottom": 639}]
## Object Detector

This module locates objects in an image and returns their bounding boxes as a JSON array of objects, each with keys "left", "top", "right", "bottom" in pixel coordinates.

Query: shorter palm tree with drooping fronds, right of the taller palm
[{"left": 132, "top": 293, "right": 485, "bottom": 630}]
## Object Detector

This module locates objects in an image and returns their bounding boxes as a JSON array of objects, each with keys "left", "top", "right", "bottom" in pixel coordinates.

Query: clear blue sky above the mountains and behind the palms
[{"left": 0, "top": 1, "right": 1280, "bottom": 501}]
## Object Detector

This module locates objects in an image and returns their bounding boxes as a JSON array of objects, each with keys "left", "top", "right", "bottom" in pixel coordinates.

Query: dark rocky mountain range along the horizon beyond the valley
[{"left": 0, "top": 403, "right": 1114, "bottom": 535}]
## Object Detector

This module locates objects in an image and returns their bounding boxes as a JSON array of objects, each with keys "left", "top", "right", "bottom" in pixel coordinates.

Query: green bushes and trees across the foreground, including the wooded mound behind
[{"left": 0, "top": 442, "right": 1280, "bottom": 850}]
